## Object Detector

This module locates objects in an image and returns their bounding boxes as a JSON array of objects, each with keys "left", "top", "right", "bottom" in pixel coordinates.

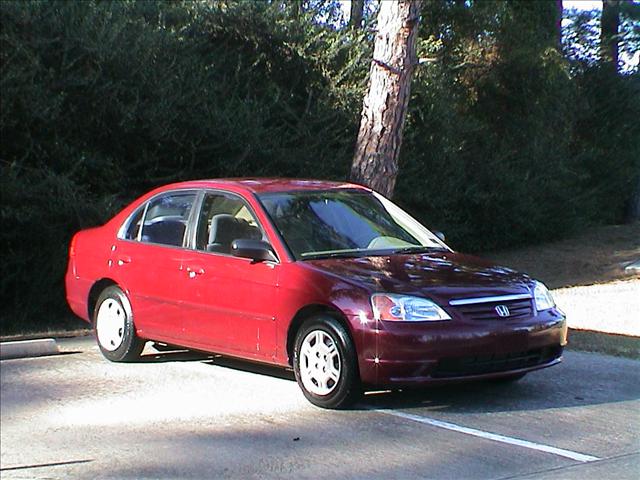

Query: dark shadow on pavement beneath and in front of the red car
[{"left": 140, "top": 350, "right": 640, "bottom": 413}]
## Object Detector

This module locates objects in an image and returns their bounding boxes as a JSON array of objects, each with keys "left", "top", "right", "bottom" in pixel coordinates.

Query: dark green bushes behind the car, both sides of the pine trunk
[{"left": 0, "top": 1, "right": 640, "bottom": 333}]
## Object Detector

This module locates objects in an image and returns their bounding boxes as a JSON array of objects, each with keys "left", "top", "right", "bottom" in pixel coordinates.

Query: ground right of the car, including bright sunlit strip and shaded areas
[{"left": 483, "top": 223, "right": 640, "bottom": 346}]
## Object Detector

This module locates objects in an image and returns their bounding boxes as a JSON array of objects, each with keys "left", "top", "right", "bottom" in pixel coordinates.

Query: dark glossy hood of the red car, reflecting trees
[{"left": 302, "top": 252, "right": 532, "bottom": 301}]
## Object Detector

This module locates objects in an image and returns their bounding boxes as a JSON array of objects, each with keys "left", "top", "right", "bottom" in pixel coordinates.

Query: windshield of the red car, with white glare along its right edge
[{"left": 259, "top": 189, "right": 448, "bottom": 260}]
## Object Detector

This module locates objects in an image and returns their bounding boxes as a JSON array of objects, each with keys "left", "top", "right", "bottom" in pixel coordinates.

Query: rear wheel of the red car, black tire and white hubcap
[{"left": 92, "top": 286, "right": 145, "bottom": 362}]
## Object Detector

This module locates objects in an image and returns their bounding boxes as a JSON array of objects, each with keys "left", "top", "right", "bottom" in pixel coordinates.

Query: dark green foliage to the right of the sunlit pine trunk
[{"left": 397, "top": 1, "right": 640, "bottom": 250}]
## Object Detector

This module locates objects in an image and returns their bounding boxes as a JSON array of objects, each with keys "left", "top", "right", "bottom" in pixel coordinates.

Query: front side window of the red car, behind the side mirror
[{"left": 196, "top": 193, "right": 264, "bottom": 254}]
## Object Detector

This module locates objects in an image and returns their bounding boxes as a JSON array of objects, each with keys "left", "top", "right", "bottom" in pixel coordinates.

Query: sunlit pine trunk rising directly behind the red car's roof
[{"left": 350, "top": 0, "right": 420, "bottom": 197}]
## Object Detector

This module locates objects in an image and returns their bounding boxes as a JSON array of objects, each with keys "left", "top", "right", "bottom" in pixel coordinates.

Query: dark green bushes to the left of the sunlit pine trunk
[{"left": 0, "top": 1, "right": 366, "bottom": 331}]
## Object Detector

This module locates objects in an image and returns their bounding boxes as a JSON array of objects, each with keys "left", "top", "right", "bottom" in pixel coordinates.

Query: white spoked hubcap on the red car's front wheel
[{"left": 300, "top": 330, "right": 342, "bottom": 395}]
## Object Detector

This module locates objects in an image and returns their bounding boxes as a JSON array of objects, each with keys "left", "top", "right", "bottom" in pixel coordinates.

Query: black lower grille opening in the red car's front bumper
[{"left": 431, "top": 347, "right": 562, "bottom": 378}]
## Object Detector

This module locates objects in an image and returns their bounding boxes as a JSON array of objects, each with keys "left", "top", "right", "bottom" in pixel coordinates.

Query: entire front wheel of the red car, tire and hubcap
[{"left": 293, "top": 316, "right": 361, "bottom": 408}]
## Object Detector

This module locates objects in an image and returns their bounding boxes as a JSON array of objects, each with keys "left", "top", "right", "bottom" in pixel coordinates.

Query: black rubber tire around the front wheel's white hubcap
[{"left": 293, "top": 316, "right": 362, "bottom": 409}]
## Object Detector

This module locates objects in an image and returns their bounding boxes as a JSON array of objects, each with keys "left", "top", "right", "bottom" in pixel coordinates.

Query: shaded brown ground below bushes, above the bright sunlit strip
[{"left": 481, "top": 222, "right": 640, "bottom": 289}]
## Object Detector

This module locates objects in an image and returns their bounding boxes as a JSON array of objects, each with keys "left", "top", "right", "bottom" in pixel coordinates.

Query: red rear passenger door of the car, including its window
[{"left": 111, "top": 191, "right": 196, "bottom": 340}]
